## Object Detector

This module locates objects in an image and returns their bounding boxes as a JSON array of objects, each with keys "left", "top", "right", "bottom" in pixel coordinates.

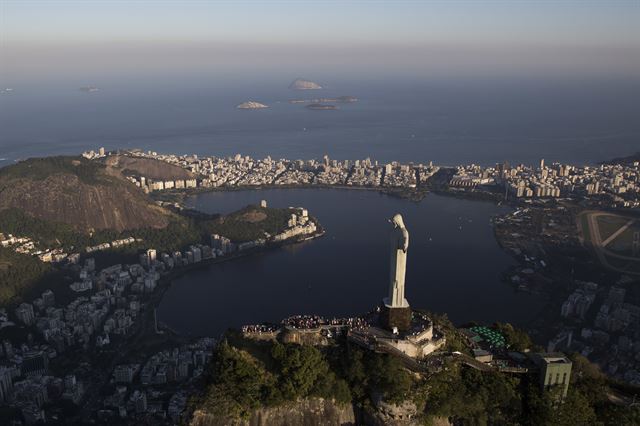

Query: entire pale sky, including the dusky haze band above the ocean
[{"left": 0, "top": 0, "right": 640, "bottom": 78}]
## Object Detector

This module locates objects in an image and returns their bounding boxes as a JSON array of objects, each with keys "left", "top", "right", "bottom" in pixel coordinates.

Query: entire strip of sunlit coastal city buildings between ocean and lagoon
[{"left": 83, "top": 148, "right": 640, "bottom": 208}]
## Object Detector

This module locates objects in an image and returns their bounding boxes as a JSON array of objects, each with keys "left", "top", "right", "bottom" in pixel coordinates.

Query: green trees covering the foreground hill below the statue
[{"left": 190, "top": 326, "right": 640, "bottom": 426}]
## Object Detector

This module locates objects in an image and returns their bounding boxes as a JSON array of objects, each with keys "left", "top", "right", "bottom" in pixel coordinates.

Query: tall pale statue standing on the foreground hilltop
[{"left": 384, "top": 214, "right": 409, "bottom": 308}]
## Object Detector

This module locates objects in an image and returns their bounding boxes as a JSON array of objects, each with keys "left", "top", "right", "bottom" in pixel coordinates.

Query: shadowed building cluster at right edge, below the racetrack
[{"left": 548, "top": 282, "right": 640, "bottom": 385}]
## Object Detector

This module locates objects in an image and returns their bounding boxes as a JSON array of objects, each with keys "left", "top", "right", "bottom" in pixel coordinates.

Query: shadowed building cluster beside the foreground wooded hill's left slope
[{"left": 100, "top": 338, "right": 216, "bottom": 423}]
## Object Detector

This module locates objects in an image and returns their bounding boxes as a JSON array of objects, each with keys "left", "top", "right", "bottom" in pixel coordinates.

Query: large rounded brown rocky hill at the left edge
[{"left": 0, "top": 157, "right": 169, "bottom": 231}]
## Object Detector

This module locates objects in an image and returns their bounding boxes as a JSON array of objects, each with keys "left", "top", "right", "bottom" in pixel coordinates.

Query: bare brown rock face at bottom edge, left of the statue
[{"left": 190, "top": 398, "right": 356, "bottom": 426}]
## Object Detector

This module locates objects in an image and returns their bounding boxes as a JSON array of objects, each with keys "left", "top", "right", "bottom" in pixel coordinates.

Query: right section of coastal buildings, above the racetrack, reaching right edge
[{"left": 449, "top": 160, "right": 640, "bottom": 207}]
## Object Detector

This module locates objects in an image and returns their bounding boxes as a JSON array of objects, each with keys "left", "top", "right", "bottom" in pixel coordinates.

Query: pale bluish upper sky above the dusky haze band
[{"left": 1, "top": 0, "right": 640, "bottom": 45}]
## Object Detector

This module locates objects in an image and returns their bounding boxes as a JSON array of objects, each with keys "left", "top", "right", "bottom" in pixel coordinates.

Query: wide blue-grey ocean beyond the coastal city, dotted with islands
[{"left": 0, "top": 75, "right": 640, "bottom": 165}]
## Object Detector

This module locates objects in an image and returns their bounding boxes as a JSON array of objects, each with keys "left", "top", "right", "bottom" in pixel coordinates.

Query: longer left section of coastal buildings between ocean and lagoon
[{"left": 119, "top": 150, "right": 438, "bottom": 191}]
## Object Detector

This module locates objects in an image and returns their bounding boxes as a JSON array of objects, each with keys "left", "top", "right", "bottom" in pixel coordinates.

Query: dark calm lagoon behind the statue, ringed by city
[{"left": 158, "top": 189, "right": 543, "bottom": 336}]
